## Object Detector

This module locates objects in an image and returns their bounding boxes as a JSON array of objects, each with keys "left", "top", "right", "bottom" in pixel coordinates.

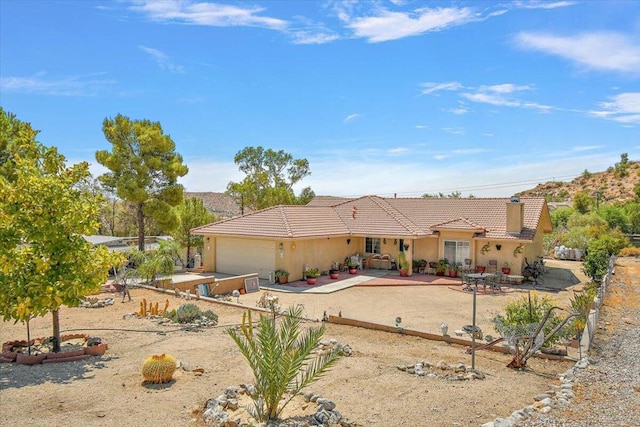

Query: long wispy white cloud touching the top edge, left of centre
[{"left": 131, "top": 0, "right": 288, "bottom": 30}]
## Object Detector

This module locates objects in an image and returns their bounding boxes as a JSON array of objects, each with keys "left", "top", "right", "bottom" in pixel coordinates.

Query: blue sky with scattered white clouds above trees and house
[{"left": 0, "top": 0, "right": 640, "bottom": 197}]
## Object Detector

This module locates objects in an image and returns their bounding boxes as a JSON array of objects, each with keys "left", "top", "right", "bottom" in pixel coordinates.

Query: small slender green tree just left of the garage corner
[{"left": 171, "top": 197, "right": 216, "bottom": 262}]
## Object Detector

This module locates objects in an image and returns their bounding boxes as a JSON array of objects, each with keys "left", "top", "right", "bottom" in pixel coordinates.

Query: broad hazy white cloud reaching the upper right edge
[{"left": 515, "top": 32, "right": 640, "bottom": 73}]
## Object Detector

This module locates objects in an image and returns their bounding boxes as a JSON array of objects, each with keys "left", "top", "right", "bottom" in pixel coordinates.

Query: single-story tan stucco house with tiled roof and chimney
[{"left": 192, "top": 196, "right": 552, "bottom": 280}]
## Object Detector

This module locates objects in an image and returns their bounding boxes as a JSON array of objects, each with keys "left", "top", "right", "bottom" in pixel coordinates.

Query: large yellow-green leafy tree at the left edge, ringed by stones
[{"left": 0, "top": 108, "right": 121, "bottom": 352}]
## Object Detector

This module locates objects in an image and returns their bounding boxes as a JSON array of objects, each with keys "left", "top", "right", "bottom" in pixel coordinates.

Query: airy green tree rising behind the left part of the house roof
[{"left": 226, "top": 147, "right": 315, "bottom": 213}]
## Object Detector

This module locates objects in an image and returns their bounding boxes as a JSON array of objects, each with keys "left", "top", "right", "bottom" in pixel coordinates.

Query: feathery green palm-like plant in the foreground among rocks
[{"left": 227, "top": 306, "right": 340, "bottom": 422}]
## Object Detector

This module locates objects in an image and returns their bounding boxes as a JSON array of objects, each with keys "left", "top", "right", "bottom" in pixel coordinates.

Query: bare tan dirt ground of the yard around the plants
[{"left": 0, "top": 262, "right": 596, "bottom": 427}]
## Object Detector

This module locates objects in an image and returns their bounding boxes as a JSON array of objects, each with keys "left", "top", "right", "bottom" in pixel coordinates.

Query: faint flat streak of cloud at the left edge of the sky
[{"left": 0, "top": 73, "right": 116, "bottom": 96}]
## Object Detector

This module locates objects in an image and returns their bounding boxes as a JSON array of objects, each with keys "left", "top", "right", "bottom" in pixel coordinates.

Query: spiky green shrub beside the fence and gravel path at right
[{"left": 493, "top": 291, "right": 566, "bottom": 347}]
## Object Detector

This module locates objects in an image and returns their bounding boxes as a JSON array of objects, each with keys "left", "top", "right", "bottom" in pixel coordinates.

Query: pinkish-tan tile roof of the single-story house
[{"left": 193, "top": 196, "right": 550, "bottom": 240}]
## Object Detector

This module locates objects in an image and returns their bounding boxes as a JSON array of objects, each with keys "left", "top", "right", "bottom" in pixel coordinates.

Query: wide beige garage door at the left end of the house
[{"left": 216, "top": 238, "right": 276, "bottom": 279}]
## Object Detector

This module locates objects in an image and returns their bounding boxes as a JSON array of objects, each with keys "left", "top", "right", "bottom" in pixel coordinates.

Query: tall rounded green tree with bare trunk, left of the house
[{"left": 96, "top": 114, "right": 189, "bottom": 250}]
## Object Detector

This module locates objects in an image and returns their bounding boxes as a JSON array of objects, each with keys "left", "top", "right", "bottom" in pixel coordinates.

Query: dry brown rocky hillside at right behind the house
[{"left": 518, "top": 162, "right": 640, "bottom": 203}]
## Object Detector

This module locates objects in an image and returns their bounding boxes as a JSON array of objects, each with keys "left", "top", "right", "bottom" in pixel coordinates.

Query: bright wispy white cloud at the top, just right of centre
[{"left": 340, "top": 7, "right": 478, "bottom": 43}]
